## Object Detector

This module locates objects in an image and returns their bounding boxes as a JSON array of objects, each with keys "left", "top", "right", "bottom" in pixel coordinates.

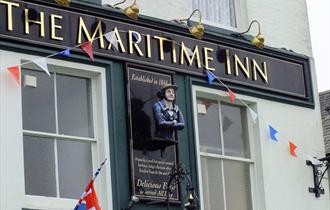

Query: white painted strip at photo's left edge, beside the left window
[{"left": 0, "top": 50, "right": 24, "bottom": 210}]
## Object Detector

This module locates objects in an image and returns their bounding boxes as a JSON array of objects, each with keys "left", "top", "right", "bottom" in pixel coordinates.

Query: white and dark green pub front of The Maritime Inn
[{"left": 0, "top": 0, "right": 330, "bottom": 210}]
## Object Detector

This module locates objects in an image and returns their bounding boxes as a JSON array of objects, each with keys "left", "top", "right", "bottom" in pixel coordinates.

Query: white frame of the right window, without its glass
[{"left": 192, "top": 85, "right": 265, "bottom": 210}]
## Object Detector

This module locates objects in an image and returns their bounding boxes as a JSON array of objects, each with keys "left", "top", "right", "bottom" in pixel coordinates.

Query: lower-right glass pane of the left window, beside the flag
[{"left": 57, "top": 140, "right": 93, "bottom": 199}]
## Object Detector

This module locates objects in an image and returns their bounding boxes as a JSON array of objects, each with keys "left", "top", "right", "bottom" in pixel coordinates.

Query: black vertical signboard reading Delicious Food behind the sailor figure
[{"left": 127, "top": 67, "right": 180, "bottom": 201}]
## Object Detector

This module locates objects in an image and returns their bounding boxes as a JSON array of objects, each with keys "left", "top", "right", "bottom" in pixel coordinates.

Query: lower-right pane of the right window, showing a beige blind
[{"left": 223, "top": 160, "right": 252, "bottom": 210}]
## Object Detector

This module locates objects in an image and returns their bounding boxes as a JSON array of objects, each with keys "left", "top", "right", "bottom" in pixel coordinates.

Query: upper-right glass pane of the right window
[{"left": 221, "top": 104, "right": 250, "bottom": 158}]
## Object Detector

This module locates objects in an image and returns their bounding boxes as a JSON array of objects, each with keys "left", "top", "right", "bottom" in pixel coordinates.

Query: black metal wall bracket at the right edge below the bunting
[{"left": 306, "top": 153, "right": 330, "bottom": 198}]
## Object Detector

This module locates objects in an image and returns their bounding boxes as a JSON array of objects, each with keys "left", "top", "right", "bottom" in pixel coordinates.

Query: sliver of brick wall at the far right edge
[{"left": 319, "top": 90, "right": 330, "bottom": 153}]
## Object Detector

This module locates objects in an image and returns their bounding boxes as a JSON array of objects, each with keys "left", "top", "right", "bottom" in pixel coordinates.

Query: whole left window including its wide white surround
[{"left": 0, "top": 50, "right": 112, "bottom": 210}]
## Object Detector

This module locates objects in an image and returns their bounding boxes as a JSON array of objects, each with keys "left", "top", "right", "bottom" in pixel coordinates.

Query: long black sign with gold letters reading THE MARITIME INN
[{"left": 0, "top": 0, "right": 313, "bottom": 105}]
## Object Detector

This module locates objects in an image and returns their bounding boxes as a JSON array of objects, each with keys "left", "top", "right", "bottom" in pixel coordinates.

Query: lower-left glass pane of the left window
[{"left": 23, "top": 135, "right": 56, "bottom": 197}]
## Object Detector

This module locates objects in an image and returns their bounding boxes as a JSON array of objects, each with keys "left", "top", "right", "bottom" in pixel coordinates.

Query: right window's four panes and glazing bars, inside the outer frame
[{"left": 195, "top": 88, "right": 254, "bottom": 210}]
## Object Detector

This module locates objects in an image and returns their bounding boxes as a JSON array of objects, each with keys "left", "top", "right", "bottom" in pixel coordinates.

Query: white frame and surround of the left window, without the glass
[{"left": 0, "top": 50, "right": 113, "bottom": 210}]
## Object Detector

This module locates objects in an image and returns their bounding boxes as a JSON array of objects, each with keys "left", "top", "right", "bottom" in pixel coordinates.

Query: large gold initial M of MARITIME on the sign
[{"left": 78, "top": 17, "right": 104, "bottom": 48}]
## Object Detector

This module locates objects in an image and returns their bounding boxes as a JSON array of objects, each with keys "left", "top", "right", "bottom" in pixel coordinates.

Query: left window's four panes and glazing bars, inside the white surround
[{"left": 22, "top": 68, "right": 96, "bottom": 199}]
